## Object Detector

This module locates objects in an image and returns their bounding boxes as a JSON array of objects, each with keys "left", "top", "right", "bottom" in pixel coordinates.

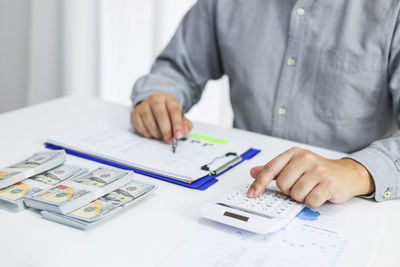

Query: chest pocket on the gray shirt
[{"left": 313, "top": 50, "right": 387, "bottom": 120}]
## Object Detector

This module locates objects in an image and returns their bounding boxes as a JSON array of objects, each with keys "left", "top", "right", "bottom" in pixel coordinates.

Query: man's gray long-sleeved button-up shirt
[{"left": 132, "top": 0, "right": 400, "bottom": 201}]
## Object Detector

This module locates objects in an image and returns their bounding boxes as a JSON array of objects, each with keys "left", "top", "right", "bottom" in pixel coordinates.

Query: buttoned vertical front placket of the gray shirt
[{"left": 272, "top": 0, "right": 313, "bottom": 138}]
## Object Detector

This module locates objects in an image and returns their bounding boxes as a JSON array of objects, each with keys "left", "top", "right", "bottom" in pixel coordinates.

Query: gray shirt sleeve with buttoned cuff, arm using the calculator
[{"left": 349, "top": 15, "right": 400, "bottom": 201}]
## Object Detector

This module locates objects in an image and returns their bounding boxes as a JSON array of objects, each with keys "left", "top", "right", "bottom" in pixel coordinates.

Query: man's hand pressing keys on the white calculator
[{"left": 247, "top": 147, "right": 375, "bottom": 208}]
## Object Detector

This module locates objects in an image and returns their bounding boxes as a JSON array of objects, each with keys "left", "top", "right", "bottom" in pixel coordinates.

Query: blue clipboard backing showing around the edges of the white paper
[{"left": 45, "top": 143, "right": 261, "bottom": 191}]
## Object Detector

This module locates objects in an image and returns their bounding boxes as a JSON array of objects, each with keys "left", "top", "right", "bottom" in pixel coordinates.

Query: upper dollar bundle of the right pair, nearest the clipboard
[{"left": 25, "top": 168, "right": 134, "bottom": 214}]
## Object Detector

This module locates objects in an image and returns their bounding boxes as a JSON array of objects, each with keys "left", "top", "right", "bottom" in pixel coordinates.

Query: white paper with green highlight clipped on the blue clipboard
[{"left": 48, "top": 121, "right": 249, "bottom": 182}]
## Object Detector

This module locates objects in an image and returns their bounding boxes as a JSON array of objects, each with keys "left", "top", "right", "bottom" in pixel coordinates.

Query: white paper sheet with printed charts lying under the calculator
[{"left": 160, "top": 205, "right": 386, "bottom": 267}]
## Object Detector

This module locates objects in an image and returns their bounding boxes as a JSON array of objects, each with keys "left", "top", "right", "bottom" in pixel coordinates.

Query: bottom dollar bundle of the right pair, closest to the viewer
[{"left": 41, "top": 181, "right": 157, "bottom": 230}]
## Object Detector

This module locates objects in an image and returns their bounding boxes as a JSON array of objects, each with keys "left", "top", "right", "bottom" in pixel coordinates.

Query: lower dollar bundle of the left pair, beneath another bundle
[{"left": 0, "top": 164, "right": 88, "bottom": 212}]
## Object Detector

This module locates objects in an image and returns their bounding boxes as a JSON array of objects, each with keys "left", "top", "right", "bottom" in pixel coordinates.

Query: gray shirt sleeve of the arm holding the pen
[{"left": 131, "top": 0, "right": 223, "bottom": 112}]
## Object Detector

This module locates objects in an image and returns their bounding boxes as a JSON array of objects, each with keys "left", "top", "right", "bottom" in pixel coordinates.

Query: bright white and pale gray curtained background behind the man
[{"left": 0, "top": 0, "right": 233, "bottom": 126}]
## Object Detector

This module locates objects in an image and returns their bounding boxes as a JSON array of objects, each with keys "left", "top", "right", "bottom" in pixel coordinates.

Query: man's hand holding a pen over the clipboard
[{"left": 131, "top": 93, "right": 192, "bottom": 144}]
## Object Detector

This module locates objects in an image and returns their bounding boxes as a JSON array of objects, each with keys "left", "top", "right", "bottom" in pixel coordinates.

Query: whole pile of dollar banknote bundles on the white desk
[{"left": 0, "top": 150, "right": 156, "bottom": 229}]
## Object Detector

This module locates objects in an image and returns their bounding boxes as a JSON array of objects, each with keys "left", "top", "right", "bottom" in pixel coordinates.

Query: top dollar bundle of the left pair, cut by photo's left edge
[{"left": 0, "top": 150, "right": 66, "bottom": 188}]
